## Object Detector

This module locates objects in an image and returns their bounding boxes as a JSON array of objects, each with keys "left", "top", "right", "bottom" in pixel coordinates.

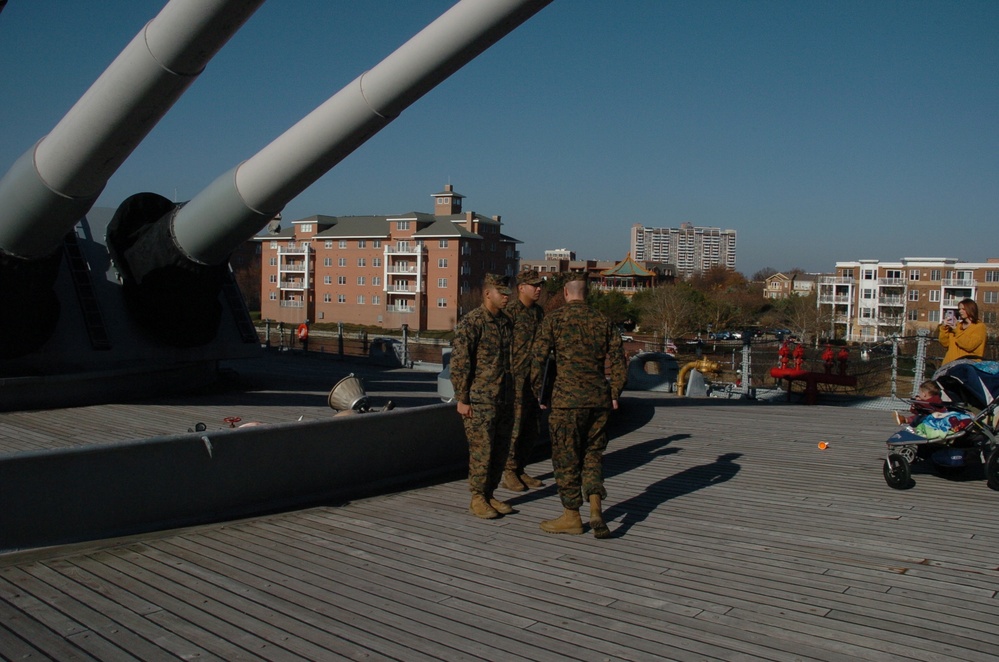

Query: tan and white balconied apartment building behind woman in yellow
[{"left": 818, "top": 257, "right": 999, "bottom": 342}]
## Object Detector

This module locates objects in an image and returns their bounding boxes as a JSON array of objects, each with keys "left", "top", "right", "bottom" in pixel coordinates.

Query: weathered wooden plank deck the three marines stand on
[{"left": 0, "top": 358, "right": 999, "bottom": 661}]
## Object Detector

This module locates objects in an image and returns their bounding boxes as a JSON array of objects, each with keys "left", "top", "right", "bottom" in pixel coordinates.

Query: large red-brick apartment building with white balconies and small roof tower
[{"left": 254, "top": 184, "right": 520, "bottom": 331}]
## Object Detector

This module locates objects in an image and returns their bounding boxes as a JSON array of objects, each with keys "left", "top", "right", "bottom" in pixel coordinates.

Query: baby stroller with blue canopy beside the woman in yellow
[{"left": 883, "top": 359, "right": 999, "bottom": 490}]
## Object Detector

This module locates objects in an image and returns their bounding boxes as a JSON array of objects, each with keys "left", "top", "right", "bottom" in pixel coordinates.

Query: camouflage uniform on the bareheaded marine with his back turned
[{"left": 531, "top": 301, "right": 627, "bottom": 510}]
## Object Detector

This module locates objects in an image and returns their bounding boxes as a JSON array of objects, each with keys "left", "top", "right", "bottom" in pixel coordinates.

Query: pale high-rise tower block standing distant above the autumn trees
[{"left": 631, "top": 223, "right": 735, "bottom": 278}]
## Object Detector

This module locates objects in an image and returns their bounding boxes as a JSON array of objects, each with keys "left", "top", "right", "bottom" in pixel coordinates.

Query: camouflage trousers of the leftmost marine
[{"left": 464, "top": 403, "right": 513, "bottom": 497}]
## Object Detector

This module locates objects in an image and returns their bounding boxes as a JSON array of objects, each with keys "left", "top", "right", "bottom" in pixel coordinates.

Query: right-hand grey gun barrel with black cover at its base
[{"left": 107, "top": 0, "right": 551, "bottom": 346}]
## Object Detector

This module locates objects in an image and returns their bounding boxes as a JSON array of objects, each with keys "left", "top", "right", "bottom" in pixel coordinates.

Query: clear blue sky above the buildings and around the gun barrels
[{"left": 0, "top": 0, "right": 999, "bottom": 275}]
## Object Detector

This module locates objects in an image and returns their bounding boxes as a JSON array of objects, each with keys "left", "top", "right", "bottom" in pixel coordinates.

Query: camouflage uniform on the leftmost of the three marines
[{"left": 450, "top": 306, "right": 513, "bottom": 498}]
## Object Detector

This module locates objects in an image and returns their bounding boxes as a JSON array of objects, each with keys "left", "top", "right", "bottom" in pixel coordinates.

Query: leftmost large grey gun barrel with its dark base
[{"left": 0, "top": 0, "right": 263, "bottom": 356}]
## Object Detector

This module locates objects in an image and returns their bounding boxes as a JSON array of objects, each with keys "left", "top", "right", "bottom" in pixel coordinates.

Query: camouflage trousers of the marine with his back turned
[{"left": 548, "top": 407, "right": 609, "bottom": 510}]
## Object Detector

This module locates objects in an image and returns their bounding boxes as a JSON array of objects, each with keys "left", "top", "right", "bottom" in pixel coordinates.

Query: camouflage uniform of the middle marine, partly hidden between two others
[{"left": 503, "top": 298, "right": 545, "bottom": 476}]
